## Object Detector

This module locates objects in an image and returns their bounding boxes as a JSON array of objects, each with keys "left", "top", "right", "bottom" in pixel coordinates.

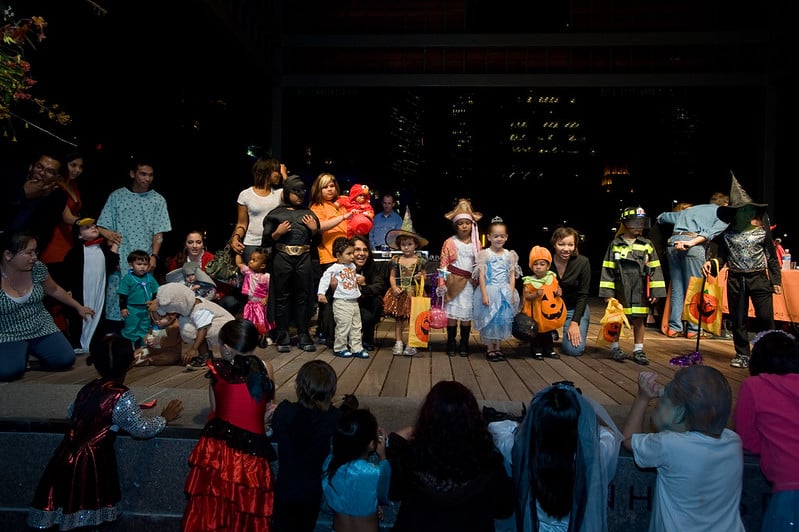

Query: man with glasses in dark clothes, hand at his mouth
[{"left": 0, "top": 149, "right": 67, "bottom": 249}]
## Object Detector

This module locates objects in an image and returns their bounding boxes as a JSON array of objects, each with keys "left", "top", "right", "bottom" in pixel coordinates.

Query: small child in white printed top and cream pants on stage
[{"left": 316, "top": 236, "right": 369, "bottom": 358}]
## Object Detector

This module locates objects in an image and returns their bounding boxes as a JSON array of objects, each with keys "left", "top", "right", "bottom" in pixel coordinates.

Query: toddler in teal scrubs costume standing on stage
[{"left": 117, "top": 249, "right": 158, "bottom": 347}]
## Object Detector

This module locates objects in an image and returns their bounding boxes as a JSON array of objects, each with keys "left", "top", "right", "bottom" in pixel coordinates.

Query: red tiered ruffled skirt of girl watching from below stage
[{"left": 183, "top": 436, "right": 274, "bottom": 532}]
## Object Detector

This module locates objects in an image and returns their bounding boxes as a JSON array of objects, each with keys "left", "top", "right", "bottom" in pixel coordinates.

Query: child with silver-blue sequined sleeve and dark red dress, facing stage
[{"left": 28, "top": 335, "right": 183, "bottom": 530}]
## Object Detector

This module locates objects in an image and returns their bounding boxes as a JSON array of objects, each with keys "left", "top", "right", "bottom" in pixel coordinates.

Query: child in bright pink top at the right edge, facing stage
[{"left": 733, "top": 331, "right": 799, "bottom": 532}]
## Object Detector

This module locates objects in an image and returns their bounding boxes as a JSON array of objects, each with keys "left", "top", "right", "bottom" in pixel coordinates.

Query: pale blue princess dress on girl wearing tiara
[{"left": 472, "top": 248, "right": 522, "bottom": 343}]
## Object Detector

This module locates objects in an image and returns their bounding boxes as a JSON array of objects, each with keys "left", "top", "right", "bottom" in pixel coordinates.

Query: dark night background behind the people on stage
[{"left": 0, "top": 0, "right": 797, "bottom": 274}]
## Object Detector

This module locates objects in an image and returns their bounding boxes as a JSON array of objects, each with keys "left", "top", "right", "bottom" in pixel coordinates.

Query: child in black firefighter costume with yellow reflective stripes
[{"left": 599, "top": 207, "right": 666, "bottom": 366}]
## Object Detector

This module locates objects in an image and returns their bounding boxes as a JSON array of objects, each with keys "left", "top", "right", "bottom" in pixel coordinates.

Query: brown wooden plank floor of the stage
[{"left": 18, "top": 299, "right": 749, "bottom": 411}]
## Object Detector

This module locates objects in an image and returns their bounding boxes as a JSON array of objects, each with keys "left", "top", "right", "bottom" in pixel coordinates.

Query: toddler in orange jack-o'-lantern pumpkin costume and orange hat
[{"left": 522, "top": 246, "right": 566, "bottom": 360}]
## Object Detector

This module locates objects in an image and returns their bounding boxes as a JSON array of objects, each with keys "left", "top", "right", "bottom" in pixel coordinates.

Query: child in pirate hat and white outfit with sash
[{"left": 437, "top": 198, "right": 483, "bottom": 356}]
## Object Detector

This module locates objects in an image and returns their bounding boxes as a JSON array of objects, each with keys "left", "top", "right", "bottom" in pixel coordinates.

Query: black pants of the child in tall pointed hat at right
[{"left": 727, "top": 270, "right": 774, "bottom": 357}]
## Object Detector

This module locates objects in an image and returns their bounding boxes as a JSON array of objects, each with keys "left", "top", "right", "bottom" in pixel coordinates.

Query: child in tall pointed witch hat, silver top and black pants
[{"left": 702, "top": 175, "right": 782, "bottom": 368}]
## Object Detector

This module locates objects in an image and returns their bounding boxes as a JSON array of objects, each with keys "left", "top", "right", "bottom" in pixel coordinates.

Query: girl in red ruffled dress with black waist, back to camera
[{"left": 183, "top": 318, "right": 278, "bottom": 532}]
